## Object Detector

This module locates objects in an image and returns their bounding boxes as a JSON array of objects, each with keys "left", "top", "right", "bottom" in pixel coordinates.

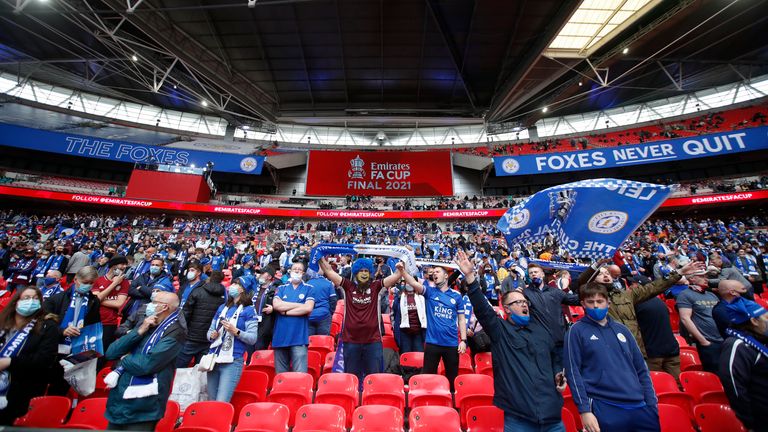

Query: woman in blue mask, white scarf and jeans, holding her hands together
[{"left": 208, "top": 284, "right": 258, "bottom": 402}]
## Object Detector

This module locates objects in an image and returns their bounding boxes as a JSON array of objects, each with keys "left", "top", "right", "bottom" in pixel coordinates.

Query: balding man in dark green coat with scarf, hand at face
[{"left": 104, "top": 291, "right": 187, "bottom": 431}]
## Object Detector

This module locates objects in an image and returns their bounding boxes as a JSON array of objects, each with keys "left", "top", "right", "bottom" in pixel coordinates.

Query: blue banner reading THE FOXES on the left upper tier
[{"left": 0, "top": 124, "right": 264, "bottom": 174}]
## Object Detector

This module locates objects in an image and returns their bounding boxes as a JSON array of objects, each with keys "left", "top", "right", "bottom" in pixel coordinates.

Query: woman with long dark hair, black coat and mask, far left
[{"left": 0, "top": 286, "right": 59, "bottom": 425}]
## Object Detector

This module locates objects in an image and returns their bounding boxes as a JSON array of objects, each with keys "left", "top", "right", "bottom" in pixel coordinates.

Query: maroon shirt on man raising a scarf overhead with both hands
[{"left": 341, "top": 278, "right": 384, "bottom": 343}]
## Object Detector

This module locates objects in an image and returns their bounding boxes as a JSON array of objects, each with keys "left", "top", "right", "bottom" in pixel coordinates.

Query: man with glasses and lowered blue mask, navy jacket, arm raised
[{"left": 456, "top": 250, "right": 566, "bottom": 432}]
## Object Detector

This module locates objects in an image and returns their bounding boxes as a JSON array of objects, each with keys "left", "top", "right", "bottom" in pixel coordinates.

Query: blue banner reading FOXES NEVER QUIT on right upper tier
[{"left": 493, "top": 126, "right": 768, "bottom": 176}]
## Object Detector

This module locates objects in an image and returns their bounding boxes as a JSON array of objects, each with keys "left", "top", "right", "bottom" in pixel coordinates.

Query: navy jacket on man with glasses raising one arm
[{"left": 468, "top": 279, "right": 563, "bottom": 425}]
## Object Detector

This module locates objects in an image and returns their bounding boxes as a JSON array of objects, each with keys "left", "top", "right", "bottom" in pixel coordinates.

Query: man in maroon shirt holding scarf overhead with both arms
[{"left": 320, "top": 258, "right": 402, "bottom": 387}]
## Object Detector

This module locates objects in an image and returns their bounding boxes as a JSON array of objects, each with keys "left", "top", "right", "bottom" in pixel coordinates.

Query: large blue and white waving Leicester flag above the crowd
[{"left": 497, "top": 179, "right": 672, "bottom": 260}]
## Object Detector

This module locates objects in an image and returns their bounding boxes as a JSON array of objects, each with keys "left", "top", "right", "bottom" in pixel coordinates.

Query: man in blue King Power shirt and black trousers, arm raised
[{"left": 402, "top": 263, "right": 467, "bottom": 391}]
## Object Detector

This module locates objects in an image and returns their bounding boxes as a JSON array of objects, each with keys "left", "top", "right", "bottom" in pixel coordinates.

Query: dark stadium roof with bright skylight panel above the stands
[{"left": 0, "top": 0, "right": 768, "bottom": 126}]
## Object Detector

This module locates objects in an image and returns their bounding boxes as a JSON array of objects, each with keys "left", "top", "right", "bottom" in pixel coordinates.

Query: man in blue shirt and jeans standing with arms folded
[{"left": 272, "top": 262, "right": 316, "bottom": 373}]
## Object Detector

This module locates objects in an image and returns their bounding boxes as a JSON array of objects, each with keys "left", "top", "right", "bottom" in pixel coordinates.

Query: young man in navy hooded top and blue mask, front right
[{"left": 565, "top": 282, "right": 660, "bottom": 432}]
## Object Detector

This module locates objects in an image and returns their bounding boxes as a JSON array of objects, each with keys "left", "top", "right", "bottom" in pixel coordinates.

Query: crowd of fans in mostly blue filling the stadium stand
[{"left": 0, "top": 208, "right": 768, "bottom": 430}]
